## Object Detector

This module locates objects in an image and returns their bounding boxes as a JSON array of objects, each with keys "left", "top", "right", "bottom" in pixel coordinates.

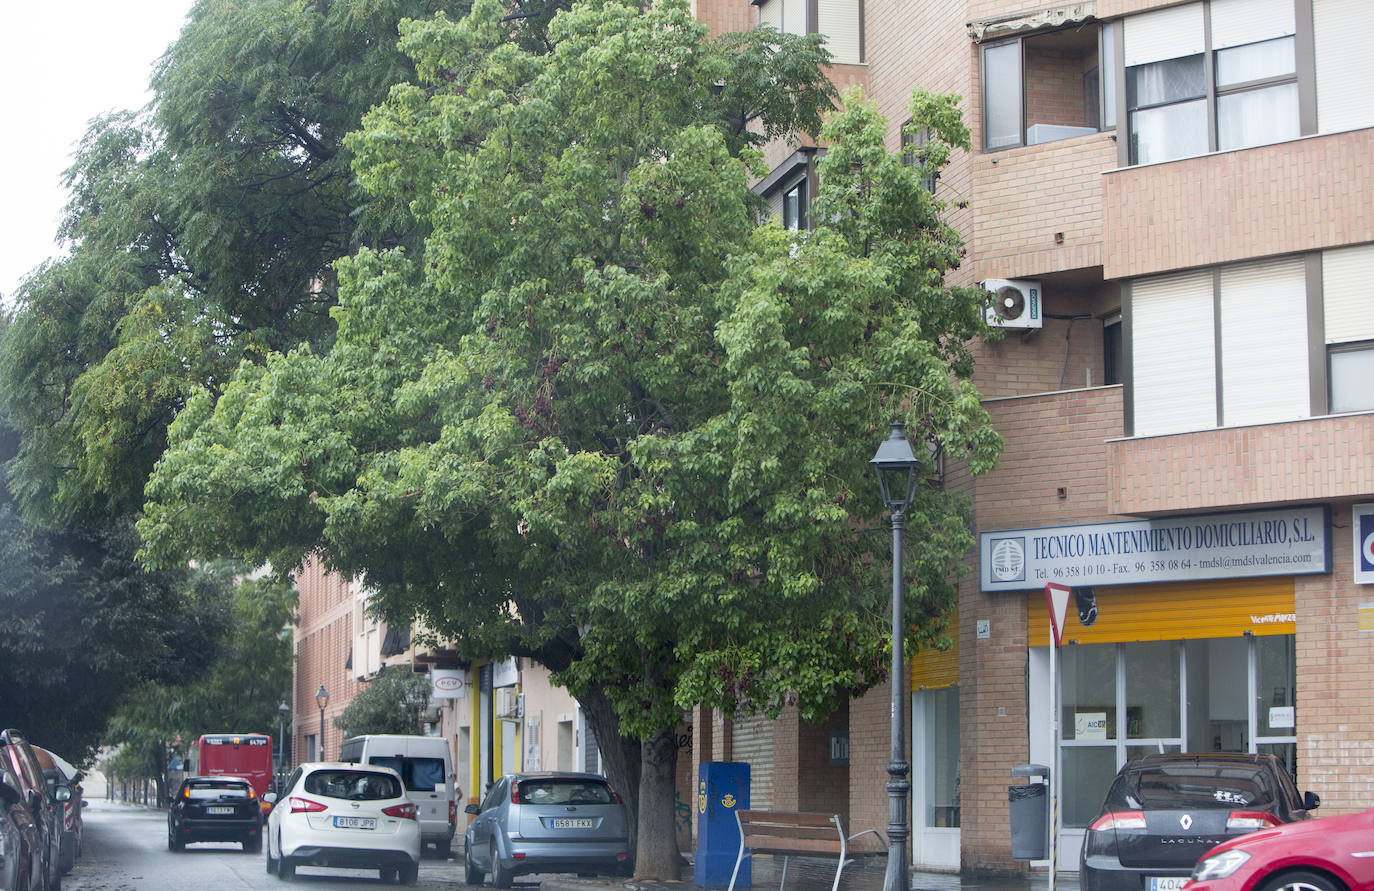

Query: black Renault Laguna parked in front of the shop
[{"left": 1079, "top": 754, "right": 1320, "bottom": 891}]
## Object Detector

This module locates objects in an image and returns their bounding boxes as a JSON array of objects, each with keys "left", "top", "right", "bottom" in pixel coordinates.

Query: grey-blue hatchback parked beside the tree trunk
[{"left": 463, "top": 773, "right": 633, "bottom": 888}]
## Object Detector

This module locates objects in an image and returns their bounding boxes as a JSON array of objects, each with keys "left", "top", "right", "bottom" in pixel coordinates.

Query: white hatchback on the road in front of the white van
[{"left": 267, "top": 762, "right": 420, "bottom": 884}]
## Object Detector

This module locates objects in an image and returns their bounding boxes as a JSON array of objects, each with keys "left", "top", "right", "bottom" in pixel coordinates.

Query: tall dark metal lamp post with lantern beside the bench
[{"left": 868, "top": 424, "right": 919, "bottom": 891}]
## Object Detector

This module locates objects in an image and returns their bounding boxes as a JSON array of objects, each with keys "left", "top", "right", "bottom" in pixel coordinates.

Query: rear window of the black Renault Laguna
[{"left": 1107, "top": 765, "right": 1278, "bottom": 810}]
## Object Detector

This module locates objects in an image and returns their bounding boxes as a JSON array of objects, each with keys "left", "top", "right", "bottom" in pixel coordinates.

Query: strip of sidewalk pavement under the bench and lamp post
[{"left": 539, "top": 854, "right": 1079, "bottom": 891}]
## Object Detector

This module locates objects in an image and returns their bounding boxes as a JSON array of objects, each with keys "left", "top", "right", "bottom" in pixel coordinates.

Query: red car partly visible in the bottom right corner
[{"left": 1184, "top": 809, "right": 1374, "bottom": 891}]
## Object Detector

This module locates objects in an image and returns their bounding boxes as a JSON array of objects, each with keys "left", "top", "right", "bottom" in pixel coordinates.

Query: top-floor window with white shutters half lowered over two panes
[{"left": 1123, "top": 0, "right": 1301, "bottom": 164}]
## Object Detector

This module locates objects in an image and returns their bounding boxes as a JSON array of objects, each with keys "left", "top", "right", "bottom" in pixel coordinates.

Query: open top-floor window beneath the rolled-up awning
[{"left": 982, "top": 22, "right": 1117, "bottom": 150}]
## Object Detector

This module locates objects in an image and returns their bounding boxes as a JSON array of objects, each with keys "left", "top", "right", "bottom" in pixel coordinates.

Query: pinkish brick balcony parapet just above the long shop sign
[{"left": 1105, "top": 413, "right": 1374, "bottom": 516}]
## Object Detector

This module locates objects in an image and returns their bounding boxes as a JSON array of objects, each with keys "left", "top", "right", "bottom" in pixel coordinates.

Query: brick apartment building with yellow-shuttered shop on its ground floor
[{"left": 297, "top": 0, "right": 1374, "bottom": 872}]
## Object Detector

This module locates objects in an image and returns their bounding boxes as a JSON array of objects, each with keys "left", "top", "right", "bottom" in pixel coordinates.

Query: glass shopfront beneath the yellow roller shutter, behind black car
[{"left": 1059, "top": 635, "right": 1297, "bottom": 828}]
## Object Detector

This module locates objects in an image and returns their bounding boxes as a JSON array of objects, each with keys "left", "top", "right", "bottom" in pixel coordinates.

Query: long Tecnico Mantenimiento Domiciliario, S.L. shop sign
[{"left": 978, "top": 506, "right": 1330, "bottom": 591}]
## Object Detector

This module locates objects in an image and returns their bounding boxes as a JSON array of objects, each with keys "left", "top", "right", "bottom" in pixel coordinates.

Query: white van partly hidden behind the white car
[{"left": 339, "top": 734, "right": 462, "bottom": 855}]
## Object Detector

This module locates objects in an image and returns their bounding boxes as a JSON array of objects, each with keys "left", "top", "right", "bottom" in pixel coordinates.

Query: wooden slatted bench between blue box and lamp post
[{"left": 730, "top": 810, "right": 888, "bottom": 891}]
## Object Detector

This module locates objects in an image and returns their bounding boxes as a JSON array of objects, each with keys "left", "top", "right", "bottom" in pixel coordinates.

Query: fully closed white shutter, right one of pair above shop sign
[{"left": 1220, "top": 260, "right": 1311, "bottom": 426}]
